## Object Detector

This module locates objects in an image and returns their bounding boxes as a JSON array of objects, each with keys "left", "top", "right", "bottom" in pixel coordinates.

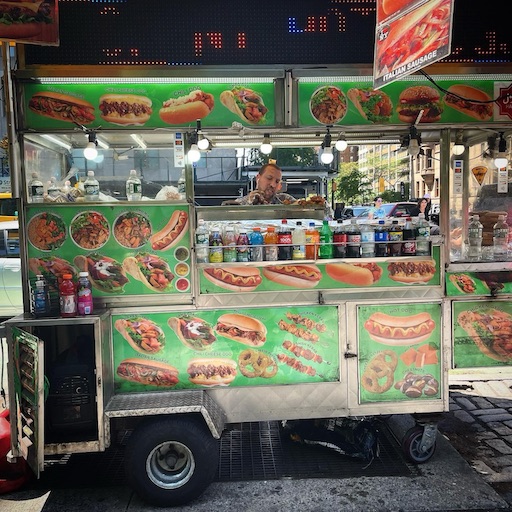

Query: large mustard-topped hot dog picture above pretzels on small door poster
[{"left": 364, "top": 312, "right": 436, "bottom": 346}]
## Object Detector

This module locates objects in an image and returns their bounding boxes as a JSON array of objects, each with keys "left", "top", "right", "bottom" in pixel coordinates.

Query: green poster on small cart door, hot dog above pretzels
[{"left": 357, "top": 303, "right": 442, "bottom": 403}]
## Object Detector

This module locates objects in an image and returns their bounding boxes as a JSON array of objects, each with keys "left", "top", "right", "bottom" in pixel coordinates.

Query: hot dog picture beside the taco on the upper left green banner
[{"left": 160, "top": 90, "right": 215, "bottom": 124}]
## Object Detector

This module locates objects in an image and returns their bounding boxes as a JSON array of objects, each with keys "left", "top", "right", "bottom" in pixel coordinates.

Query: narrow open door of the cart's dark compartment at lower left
[{"left": 9, "top": 326, "right": 45, "bottom": 478}]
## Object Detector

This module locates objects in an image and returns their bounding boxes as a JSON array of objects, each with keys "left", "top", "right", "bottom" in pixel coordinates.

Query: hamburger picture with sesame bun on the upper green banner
[{"left": 396, "top": 85, "right": 443, "bottom": 124}]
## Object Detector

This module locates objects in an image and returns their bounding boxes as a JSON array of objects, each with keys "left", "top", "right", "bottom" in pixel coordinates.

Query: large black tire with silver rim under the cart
[{"left": 124, "top": 416, "right": 219, "bottom": 507}]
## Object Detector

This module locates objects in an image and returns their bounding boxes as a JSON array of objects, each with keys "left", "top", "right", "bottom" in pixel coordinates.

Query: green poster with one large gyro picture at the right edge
[{"left": 452, "top": 300, "right": 512, "bottom": 368}]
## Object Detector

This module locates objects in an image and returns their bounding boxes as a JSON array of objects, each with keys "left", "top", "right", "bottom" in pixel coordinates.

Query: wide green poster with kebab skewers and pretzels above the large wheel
[{"left": 112, "top": 305, "right": 340, "bottom": 392}]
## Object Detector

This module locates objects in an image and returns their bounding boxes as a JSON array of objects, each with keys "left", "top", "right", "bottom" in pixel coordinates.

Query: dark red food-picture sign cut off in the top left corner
[{"left": 0, "top": 0, "right": 53, "bottom": 39}]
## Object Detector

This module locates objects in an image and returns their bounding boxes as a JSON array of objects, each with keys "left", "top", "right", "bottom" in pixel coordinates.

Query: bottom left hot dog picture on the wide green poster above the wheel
[{"left": 116, "top": 358, "right": 178, "bottom": 387}]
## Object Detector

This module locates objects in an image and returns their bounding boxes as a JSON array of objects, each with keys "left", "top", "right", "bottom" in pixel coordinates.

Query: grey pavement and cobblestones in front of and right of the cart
[{"left": 0, "top": 378, "right": 512, "bottom": 512}]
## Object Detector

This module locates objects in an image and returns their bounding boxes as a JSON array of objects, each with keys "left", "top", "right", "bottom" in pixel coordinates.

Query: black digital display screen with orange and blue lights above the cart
[{"left": 25, "top": 0, "right": 512, "bottom": 67}]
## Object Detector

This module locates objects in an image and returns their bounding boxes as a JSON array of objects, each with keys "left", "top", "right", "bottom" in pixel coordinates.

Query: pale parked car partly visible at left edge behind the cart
[{"left": 0, "top": 220, "right": 23, "bottom": 319}]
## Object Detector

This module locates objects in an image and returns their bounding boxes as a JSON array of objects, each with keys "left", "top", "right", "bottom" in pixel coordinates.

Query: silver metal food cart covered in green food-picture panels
[{"left": 2, "top": 55, "right": 511, "bottom": 505}]
